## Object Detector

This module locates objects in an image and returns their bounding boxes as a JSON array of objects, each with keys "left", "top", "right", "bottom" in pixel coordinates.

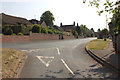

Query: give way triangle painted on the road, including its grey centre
[{"left": 37, "top": 56, "right": 54, "bottom": 67}]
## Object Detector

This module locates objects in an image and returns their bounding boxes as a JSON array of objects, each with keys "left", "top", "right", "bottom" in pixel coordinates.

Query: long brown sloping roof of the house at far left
[{"left": 0, "top": 13, "right": 32, "bottom": 25}]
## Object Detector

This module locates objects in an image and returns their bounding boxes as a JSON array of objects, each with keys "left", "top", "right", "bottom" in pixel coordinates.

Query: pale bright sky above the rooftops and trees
[{"left": 0, "top": 0, "right": 114, "bottom": 31}]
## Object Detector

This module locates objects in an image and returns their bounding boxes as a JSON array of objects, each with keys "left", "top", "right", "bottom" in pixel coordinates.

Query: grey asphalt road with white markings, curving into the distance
[{"left": 2, "top": 38, "right": 115, "bottom": 78}]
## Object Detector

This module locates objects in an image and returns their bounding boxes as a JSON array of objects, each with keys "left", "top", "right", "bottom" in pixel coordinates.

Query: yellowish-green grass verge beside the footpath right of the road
[{"left": 87, "top": 39, "right": 110, "bottom": 49}]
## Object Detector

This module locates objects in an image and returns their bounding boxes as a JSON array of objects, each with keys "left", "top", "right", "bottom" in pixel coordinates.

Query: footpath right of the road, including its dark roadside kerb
[{"left": 86, "top": 41, "right": 120, "bottom": 76}]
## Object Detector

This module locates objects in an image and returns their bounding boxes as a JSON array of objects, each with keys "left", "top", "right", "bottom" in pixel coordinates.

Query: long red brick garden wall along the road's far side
[{"left": 2, "top": 33, "right": 75, "bottom": 42}]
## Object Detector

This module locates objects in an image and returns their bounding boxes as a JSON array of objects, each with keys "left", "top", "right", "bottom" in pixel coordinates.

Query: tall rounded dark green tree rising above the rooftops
[{"left": 40, "top": 11, "right": 55, "bottom": 27}]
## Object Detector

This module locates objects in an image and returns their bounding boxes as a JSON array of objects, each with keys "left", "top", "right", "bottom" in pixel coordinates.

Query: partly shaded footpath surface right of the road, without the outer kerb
[{"left": 86, "top": 41, "right": 120, "bottom": 76}]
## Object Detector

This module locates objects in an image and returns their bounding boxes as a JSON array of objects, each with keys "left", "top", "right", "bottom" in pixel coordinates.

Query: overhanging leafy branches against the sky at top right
[{"left": 83, "top": 0, "right": 120, "bottom": 15}]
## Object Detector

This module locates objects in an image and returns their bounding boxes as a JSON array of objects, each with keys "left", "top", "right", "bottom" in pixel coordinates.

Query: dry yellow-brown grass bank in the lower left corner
[{"left": 2, "top": 48, "right": 25, "bottom": 78}]
